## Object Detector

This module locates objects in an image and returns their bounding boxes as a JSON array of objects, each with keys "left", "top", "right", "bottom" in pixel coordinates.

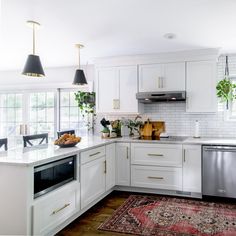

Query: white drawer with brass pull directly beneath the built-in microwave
[{"left": 33, "top": 186, "right": 77, "bottom": 235}]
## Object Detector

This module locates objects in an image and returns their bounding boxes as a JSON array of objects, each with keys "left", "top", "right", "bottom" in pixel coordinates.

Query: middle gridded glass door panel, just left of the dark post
[{"left": 28, "top": 92, "right": 55, "bottom": 137}]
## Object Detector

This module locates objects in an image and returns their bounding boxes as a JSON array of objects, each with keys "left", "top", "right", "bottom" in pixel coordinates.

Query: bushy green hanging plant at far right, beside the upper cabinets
[{"left": 216, "top": 77, "right": 236, "bottom": 109}]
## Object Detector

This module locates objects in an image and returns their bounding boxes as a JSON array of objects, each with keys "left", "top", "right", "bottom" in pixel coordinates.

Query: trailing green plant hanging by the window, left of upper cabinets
[{"left": 75, "top": 91, "right": 96, "bottom": 130}]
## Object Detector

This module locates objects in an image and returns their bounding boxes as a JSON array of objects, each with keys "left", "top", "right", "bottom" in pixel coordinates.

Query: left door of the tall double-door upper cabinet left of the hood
[{"left": 96, "top": 67, "right": 120, "bottom": 112}]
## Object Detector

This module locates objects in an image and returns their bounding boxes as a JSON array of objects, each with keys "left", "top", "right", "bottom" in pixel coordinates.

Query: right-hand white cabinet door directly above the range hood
[{"left": 163, "top": 62, "right": 185, "bottom": 91}]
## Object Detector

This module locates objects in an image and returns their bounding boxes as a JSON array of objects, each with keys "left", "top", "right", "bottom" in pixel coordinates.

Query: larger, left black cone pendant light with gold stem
[{"left": 22, "top": 21, "right": 45, "bottom": 77}]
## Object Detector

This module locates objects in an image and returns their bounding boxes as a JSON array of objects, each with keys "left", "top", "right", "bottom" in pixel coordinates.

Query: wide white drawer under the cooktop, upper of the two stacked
[{"left": 131, "top": 144, "right": 183, "bottom": 167}]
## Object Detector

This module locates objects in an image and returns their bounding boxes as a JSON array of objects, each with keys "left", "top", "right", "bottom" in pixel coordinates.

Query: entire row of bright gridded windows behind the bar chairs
[{"left": 0, "top": 89, "right": 91, "bottom": 141}]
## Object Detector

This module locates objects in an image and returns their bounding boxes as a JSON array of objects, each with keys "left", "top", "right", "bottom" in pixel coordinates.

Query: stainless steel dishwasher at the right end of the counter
[{"left": 202, "top": 146, "right": 236, "bottom": 198}]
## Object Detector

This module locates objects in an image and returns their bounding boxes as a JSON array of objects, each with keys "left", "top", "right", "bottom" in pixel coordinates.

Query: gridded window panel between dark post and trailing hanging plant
[{"left": 59, "top": 89, "right": 86, "bottom": 133}]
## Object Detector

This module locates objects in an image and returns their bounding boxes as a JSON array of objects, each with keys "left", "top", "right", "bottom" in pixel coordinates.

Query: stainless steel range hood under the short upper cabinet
[{"left": 136, "top": 91, "right": 186, "bottom": 103}]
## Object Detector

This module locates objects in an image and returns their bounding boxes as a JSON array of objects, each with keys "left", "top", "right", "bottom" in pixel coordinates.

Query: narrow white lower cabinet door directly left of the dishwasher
[{"left": 183, "top": 145, "right": 202, "bottom": 193}]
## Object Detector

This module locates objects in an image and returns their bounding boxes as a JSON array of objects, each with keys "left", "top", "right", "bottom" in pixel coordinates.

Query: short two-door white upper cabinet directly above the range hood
[{"left": 139, "top": 62, "right": 185, "bottom": 92}]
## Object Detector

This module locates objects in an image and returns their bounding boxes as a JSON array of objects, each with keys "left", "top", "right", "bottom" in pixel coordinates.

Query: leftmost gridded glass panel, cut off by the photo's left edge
[{"left": 0, "top": 93, "right": 23, "bottom": 137}]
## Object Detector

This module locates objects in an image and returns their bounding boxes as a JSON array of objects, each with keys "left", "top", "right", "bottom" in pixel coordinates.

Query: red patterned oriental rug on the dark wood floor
[{"left": 98, "top": 195, "right": 236, "bottom": 236}]
